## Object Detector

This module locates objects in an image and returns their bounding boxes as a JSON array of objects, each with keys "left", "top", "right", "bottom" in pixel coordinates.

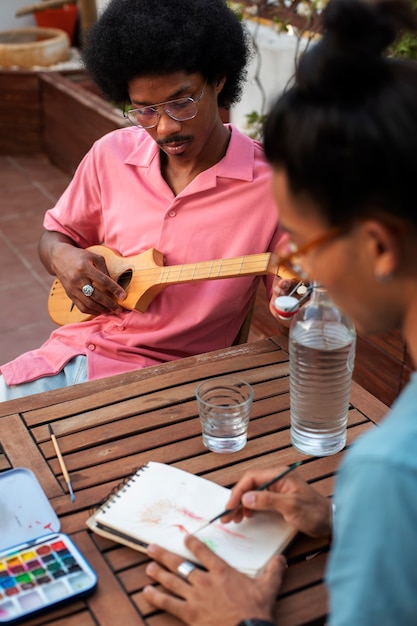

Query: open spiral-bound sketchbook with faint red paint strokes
[{"left": 87, "top": 461, "right": 296, "bottom": 577}]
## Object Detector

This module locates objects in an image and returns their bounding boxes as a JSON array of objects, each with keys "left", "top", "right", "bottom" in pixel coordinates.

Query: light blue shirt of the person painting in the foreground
[{"left": 327, "top": 373, "right": 417, "bottom": 626}]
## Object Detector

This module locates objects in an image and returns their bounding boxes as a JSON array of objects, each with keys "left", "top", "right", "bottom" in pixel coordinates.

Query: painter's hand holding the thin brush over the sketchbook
[{"left": 222, "top": 467, "right": 332, "bottom": 537}]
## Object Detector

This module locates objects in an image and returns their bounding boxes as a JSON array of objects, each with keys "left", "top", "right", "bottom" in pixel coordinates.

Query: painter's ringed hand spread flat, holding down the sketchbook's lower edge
[{"left": 143, "top": 535, "right": 286, "bottom": 626}]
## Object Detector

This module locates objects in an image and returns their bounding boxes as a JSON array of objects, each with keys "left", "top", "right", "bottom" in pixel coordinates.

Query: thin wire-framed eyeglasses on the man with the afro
[{"left": 123, "top": 81, "right": 207, "bottom": 128}]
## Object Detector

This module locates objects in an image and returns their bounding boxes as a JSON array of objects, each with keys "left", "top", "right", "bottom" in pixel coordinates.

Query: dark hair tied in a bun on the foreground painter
[{"left": 264, "top": 0, "right": 417, "bottom": 226}]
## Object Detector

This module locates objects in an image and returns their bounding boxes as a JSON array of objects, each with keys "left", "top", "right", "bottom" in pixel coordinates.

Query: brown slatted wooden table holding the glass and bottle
[{"left": 0, "top": 338, "right": 386, "bottom": 626}]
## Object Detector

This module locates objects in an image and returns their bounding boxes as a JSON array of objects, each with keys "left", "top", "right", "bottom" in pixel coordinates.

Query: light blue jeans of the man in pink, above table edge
[{"left": 0, "top": 355, "right": 87, "bottom": 402}]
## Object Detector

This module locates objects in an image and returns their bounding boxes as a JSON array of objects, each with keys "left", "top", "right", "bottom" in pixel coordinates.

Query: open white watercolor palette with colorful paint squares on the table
[{"left": 0, "top": 468, "right": 97, "bottom": 624}]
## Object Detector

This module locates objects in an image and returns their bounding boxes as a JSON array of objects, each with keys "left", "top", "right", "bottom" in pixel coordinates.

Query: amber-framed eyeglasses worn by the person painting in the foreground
[{"left": 276, "top": 223, "right": 352, "bottom": 281}]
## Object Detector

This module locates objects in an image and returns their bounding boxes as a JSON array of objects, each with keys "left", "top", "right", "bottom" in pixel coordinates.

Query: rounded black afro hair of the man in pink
[{"left": 83, "top": 0, "right": 250, "bottom": 108}]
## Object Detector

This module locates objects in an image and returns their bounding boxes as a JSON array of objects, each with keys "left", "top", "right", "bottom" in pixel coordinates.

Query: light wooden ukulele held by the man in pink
[{"left": 48, "top": 246, "right": 279, "bottom": 326}]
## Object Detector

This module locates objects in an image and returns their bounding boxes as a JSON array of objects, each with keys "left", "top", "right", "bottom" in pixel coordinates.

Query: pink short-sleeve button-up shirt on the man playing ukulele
[{"left": 1, "top": 126, "right": 281, "bottom": 385}]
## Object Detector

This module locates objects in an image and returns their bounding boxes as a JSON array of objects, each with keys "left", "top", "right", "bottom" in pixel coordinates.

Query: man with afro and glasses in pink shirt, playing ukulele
[{"left": 0, "top": 0, "right": 286, "bottom": 400}]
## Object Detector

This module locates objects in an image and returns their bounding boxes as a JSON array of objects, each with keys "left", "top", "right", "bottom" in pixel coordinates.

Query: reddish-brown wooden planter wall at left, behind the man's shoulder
[{"left": 0, "top": 70, "right": 128, "bottom": 168}]
